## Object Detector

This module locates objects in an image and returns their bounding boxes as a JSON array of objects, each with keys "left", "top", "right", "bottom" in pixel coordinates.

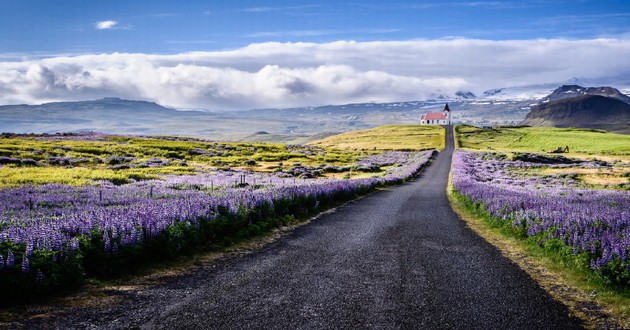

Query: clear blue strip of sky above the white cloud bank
[{"left": 0, "top": 0, "right": 630, "bottom": 54}]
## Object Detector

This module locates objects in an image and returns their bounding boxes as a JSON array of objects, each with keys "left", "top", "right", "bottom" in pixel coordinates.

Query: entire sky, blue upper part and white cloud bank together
[{"left": 0, "top": 0, "right": 630, "bottom": 110}]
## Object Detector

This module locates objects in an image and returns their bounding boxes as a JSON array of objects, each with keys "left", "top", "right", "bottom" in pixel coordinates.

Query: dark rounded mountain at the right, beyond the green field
[{"left": 522, "top": 85, "right": 630, "bottom": 133}]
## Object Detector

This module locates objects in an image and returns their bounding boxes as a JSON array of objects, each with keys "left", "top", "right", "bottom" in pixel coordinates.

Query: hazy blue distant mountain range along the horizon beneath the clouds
[{"left": 0, "top": 84, "right": 628, "bottom": 143}]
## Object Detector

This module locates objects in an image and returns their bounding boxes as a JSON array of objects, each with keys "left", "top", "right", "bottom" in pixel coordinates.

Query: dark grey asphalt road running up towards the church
[{"left": 23, "top": 125, "right": 581, "bottom": 329}]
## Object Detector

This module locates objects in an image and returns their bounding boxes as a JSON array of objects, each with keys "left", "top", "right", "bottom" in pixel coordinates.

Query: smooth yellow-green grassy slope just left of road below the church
[{"left": 310, "top": 125, "right": 444, "bottom": 150}]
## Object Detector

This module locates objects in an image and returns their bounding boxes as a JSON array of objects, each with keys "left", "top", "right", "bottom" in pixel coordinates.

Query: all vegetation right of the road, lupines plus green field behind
[{"left": 451, "top": 126, "right": 630, "bottom": 327}]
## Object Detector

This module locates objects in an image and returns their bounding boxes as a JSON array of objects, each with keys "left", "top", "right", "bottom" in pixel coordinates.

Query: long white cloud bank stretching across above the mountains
[{"left": 0, "top": 39, "right": 630, "bottom": 110}]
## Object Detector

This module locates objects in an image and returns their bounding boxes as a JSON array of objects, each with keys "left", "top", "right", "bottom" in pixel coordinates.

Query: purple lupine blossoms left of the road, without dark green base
[{"left": 0, "top": 152, "right": 432, "bottom": 278}]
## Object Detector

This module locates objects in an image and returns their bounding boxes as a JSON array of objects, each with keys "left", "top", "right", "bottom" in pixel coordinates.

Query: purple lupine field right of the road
[{"left": 452, "top": 151, "right": 630, "bottom": 287}]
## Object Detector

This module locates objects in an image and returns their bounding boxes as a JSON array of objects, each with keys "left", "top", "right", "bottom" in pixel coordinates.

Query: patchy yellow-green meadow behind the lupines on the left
[{"left": 0, "top": 134, "right": 374, "bottom": 188}]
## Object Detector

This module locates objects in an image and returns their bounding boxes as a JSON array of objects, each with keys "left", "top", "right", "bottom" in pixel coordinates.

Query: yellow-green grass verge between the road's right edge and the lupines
[{"left": 448, "top": 180, "right": 630, "bottom": 329}]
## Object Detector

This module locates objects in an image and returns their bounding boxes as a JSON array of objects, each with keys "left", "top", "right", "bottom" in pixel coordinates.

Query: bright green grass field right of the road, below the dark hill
[{"left": 455, "top": 126, "right": 630, "bottom": 156}]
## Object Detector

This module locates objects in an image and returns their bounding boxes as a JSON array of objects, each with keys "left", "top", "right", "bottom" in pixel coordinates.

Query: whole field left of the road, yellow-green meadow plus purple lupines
[{"left": 0, "top": 129, "right": 440, "bottom": 302}]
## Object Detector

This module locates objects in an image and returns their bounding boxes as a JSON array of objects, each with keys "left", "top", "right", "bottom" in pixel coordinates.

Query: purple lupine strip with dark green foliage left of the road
[{"left": 0, "top": 132, "right": 432, "bottom": 297}]
